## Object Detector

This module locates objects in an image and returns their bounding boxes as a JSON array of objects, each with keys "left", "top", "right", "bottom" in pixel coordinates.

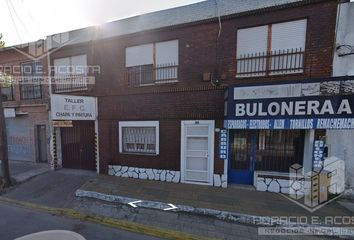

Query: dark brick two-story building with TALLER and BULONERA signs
[{"left": 45, "top": 0, "right": 352, "bottom": 192}]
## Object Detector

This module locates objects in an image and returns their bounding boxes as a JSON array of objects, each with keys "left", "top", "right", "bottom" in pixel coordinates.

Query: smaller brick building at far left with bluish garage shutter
[{"left": 0, "top": 40, "right": 50, "bottom": 162}]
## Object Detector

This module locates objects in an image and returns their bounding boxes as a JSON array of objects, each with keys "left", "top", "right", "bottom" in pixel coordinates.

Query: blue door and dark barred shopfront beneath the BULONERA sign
[{"left": 229, "top": 130, "right": 304, "bottom": 185}]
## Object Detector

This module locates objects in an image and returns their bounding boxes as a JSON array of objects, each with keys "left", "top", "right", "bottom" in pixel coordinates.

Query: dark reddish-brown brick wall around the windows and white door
[{"left": 93, "top": 1, "right": 336, "bottom": 173}]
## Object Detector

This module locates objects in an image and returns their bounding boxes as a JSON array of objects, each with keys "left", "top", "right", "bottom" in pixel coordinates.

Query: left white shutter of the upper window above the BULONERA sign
[{"left": 237, "top": 26, "right": 268, "bottom": 58}]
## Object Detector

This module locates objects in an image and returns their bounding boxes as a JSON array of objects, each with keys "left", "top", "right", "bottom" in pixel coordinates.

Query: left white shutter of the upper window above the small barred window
[{"left": 125, "top": 44, "right": 153, "bottom": 67}]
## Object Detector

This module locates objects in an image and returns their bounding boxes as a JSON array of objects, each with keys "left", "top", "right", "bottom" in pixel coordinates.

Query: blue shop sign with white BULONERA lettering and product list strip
[{"left": 225, "top": 76, "right": 354, "bottom": 129}]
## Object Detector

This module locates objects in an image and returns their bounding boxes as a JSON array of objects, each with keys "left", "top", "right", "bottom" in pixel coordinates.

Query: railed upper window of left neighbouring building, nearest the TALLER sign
[{"left": 20, "top": 61, "right": 43, "bottom": 100}]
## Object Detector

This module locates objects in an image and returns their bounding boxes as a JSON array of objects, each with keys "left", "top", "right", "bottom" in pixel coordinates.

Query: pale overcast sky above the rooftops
[{"left": 0, "top": 0, "right": 202, "bottom": 46}]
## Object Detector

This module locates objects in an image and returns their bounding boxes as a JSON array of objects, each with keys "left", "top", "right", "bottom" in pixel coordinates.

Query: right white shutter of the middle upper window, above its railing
[{"left": 156, "top": 40, "right": 178, "bottom": 67}]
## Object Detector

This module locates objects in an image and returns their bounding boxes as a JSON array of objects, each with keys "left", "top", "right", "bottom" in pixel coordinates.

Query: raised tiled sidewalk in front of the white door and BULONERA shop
[{"left": 76, "top": 175, "right": 353, "bottom": 221}]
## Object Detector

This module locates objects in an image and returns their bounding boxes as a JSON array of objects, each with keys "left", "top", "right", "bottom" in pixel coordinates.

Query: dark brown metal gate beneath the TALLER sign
[{"left": 61, "top": 121, "right": 96, "bottom": 170}]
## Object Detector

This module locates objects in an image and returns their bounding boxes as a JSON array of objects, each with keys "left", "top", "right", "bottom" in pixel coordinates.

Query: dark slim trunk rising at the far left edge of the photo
[{"left": 0, "top": 84, "right": 12, "bottom": 188}]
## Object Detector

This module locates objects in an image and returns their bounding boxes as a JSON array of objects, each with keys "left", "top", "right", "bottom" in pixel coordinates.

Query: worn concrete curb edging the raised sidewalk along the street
[{"left": 75, "top": 189, "right": 354, "bottom": 239}]
